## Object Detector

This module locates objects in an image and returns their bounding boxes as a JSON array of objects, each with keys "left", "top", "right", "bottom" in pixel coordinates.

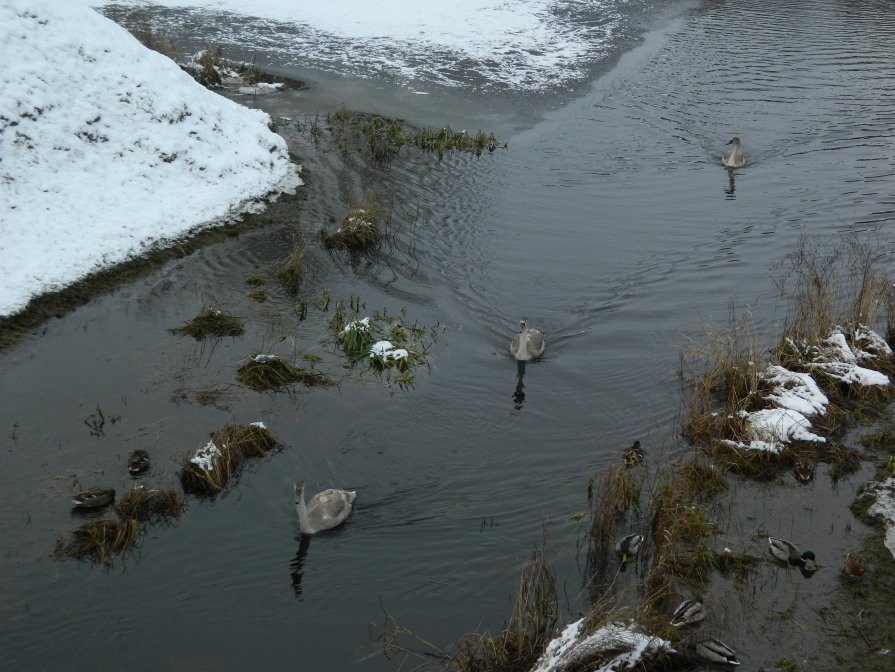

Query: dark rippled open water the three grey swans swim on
[{"left": 0, "top": 1, "right": 895, "bottom": 670}]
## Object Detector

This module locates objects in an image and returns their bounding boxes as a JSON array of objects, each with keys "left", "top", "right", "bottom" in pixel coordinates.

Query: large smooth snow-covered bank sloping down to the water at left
[{"left": 0, "top": 0, "right": 300, "bottom": 316}]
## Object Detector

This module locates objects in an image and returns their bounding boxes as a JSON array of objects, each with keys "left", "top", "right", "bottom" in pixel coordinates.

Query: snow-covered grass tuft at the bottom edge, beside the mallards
[{"left": 532, "top": 618, "right": 674, "bottom": 672}]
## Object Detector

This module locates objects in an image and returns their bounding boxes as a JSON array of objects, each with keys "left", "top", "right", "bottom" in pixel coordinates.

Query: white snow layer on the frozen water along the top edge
[{"left": 85, "top": 0, "right": 635, "bottom": 89}]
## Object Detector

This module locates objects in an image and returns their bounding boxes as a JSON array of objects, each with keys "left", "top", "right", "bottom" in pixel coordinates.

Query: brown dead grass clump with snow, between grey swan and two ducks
[{"left": 178, "top": 423, "right": 280, "bottom": 496}]
